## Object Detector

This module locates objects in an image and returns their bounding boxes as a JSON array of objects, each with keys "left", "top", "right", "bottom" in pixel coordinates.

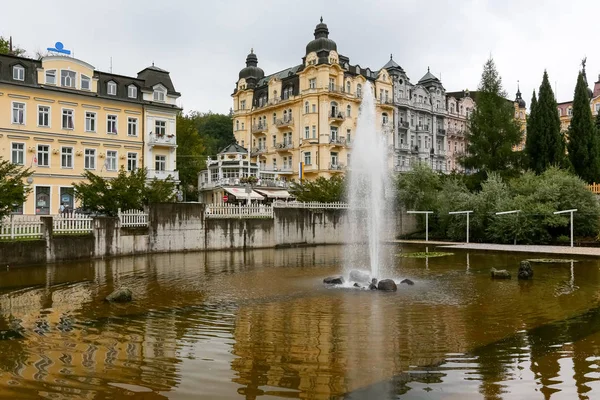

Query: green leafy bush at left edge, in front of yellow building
[{"left": 0, "top": 159, "right": 33, "bottom": 219}]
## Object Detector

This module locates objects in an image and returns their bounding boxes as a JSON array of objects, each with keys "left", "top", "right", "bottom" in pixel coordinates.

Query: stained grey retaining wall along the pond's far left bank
[{"left": 0, "top": 203, "right": 416, "bottom": 266}]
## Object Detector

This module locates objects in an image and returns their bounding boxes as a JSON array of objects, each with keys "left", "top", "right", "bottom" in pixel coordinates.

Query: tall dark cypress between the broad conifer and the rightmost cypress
[{"left": 536, "top": 71, "right": 565, "bottom": 173}]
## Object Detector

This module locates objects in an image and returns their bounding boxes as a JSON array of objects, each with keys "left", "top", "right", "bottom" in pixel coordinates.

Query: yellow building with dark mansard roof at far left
[{"left": 0, "top": 55, "right": 180, "bottom": 215}]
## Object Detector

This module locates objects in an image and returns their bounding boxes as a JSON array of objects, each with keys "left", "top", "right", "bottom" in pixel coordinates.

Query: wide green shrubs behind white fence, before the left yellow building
[{"left": 73, "top": 168, "right": 175, "bottom": 216}]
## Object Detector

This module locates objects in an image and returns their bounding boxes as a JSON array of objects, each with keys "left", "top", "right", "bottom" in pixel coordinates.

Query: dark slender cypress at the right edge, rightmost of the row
[{"left": 567, "top": 72, "right": 600, "bottom": 183}]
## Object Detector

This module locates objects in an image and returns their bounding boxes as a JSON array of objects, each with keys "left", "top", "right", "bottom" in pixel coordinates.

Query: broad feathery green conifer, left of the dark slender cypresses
[{"left": 461, "top": 58, "right": 522, "bottom": 184}]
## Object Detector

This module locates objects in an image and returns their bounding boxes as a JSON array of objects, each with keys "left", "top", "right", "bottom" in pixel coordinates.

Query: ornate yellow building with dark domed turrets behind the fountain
[{"left": 232, "top": 19, "right": 394, "bottom": 179}]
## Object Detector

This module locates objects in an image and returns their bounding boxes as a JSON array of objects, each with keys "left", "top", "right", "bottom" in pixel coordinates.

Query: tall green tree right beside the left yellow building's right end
[{"left": 177, "top": 113, "right": 207, "bottom": 199}]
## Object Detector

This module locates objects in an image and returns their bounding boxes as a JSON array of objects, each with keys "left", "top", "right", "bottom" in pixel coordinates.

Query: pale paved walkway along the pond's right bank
[{"left": 394, "top": 240, "right": 600, "bottom": 257}]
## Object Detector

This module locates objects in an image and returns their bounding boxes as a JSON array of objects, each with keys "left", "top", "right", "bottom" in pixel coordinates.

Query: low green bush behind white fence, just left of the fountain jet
[{"left": 290, "top": 175, "right": 346, "bottom": 203}]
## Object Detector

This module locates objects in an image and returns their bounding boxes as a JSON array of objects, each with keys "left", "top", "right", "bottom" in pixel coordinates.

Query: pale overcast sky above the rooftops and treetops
[{"left": 0, "top": 0, "right": 600, "bottom": 112}]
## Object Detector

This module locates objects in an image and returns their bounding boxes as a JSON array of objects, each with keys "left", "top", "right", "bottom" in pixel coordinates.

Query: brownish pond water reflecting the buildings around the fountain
[{"left": 0, "top": 245, "right": 600, "bottom": 399}]
